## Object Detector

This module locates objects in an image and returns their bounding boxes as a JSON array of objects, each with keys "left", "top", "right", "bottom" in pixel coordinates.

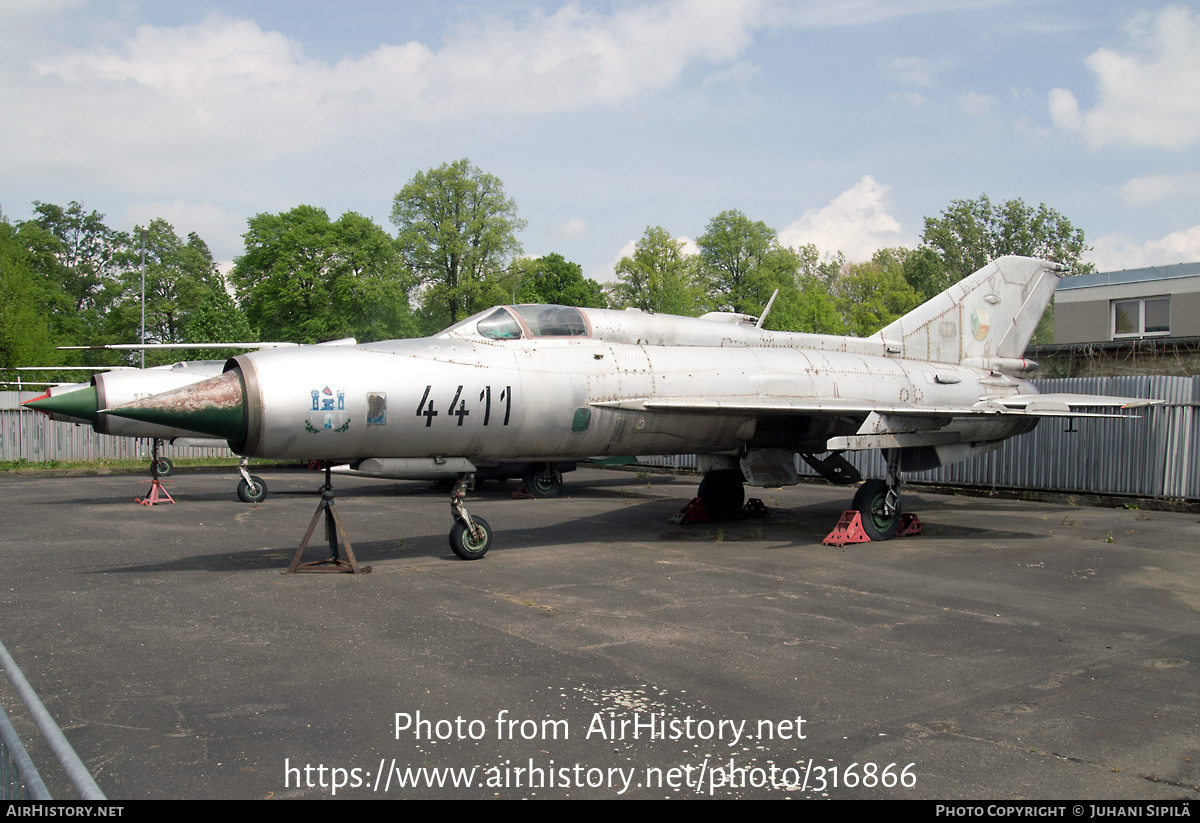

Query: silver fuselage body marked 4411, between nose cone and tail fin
[{"left": 230, "top": 306, "right": 1033, "bottom": 461}]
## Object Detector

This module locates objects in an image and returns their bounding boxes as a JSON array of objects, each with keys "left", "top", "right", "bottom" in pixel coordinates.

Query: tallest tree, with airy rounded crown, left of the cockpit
[{"left": 391, "top": 158, "right": 526, "bottom": 324}]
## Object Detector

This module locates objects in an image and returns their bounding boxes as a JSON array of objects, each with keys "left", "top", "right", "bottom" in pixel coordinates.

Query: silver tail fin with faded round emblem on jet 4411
[{"left": 875, "top": 257, "right": 1067, "bottom": 370}]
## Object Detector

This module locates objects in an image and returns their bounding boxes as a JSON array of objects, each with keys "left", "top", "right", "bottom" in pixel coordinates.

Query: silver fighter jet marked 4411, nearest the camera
[{"left": 106, "top": 257, "right": 1152, "bottom": 559}]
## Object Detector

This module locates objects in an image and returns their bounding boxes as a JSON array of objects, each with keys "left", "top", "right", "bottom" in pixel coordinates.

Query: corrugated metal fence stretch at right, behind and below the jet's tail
[{"left": 643, "top": 377, "right": 1200, "bottom": 500}]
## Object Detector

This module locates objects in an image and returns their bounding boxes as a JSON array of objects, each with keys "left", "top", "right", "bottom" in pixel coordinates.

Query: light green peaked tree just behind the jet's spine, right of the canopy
[{"left": 608, "top": 226, "right": 704, "bottom": 317}]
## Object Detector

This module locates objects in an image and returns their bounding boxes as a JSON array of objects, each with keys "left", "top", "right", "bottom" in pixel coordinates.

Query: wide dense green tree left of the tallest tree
[{"left": 230, "top": 205, "right": 416, "bottom": 343}]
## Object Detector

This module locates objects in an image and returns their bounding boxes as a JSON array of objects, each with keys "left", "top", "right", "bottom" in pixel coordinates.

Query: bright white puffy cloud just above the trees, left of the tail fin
[{"left": 779, "top": 175, "right": 905, "bottom": 263}]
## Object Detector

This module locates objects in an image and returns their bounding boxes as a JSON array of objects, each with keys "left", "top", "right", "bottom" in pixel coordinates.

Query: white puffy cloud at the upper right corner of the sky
[{"left": 1049, "top": 6, "right": 1200, "bottom": 150}]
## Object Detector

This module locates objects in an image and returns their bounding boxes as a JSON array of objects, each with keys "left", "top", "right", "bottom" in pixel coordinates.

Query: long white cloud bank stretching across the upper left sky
[{"left": 0, "top": 0, "right": 767, "bottom": 192}]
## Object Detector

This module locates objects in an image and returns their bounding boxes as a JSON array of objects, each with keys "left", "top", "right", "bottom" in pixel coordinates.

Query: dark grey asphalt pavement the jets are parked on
[{"left": 0, "top": 469, "right": 1200, "bottom": 800}]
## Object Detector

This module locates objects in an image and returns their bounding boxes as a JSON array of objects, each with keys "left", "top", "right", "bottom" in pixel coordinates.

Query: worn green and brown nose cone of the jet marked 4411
[{"left": 104, "top": 371, "right": 246, "bottom": 443}]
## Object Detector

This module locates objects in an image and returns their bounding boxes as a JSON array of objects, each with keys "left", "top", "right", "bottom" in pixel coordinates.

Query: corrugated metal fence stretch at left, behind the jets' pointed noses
[{"left": 0, "top": 391, "right": 233, "bottom": 463}]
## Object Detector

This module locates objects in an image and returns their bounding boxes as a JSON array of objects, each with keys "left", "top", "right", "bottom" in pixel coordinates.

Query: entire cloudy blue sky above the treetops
[{"left": 0, "top": 0, "right": 1200, "bottom": 280}]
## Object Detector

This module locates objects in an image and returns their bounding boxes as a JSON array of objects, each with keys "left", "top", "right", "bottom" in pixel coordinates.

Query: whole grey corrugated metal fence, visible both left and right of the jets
[{"left": 0, "top": 377, "right": 1200, "bottom": 500}]
